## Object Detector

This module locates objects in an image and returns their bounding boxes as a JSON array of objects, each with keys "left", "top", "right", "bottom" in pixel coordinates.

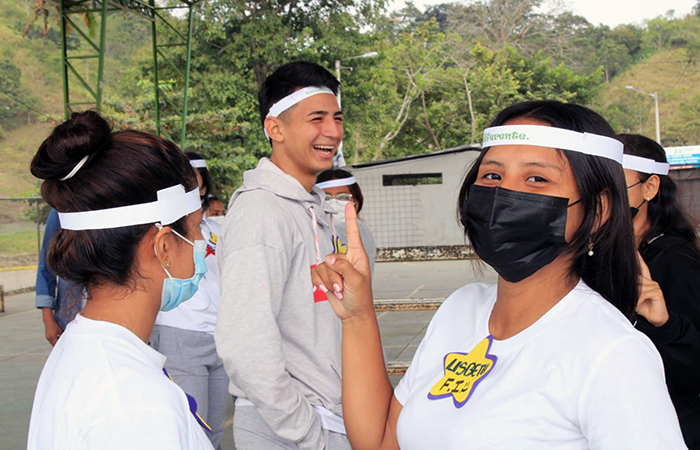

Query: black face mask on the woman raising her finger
[{"left": 461, "top": 185, "right": 580, "bottom": 283}]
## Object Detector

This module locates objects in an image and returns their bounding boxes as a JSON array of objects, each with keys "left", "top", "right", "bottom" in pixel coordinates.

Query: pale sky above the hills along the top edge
[{"left": 389, "top": 0, "right": 696, "bottom": 28}]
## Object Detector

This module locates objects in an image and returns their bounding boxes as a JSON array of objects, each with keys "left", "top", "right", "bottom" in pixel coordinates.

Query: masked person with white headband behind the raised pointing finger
[{"left": 316, "top": 169, "right": 377, "bottom": 273}]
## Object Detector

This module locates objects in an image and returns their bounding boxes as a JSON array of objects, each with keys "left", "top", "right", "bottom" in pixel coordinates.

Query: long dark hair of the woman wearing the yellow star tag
[{"left": 459, "top": 100, "right": 639, "bottom": 318}]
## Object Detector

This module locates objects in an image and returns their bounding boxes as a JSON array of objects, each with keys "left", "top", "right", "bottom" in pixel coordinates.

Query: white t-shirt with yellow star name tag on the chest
[{"left": 395, "top": 282, "right": 686, "bottom": 450}]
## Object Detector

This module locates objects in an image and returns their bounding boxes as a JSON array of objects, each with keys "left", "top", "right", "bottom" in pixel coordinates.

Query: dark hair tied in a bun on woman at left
[{"left": 31, "top": 111, "right": 197, "bottom": 289}]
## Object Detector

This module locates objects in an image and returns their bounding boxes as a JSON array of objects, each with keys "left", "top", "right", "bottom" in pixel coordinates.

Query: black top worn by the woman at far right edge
[{"left": 636, "top": 234, "right": 700, "bottom": 449}]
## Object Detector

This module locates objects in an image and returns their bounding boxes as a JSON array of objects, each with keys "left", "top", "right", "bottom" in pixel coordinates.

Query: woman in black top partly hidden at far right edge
[{"left": 618, "top": 134, "right": 700, "bottom": 449}]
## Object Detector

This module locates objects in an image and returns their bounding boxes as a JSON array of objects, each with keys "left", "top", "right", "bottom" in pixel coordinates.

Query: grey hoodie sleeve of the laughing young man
[{"left": 214, "top": 211, "right": 325, "bottom": 449}]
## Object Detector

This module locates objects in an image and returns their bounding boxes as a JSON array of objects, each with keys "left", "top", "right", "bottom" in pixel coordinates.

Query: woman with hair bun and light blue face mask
[{"left": 27, "top": 111, "right": 212, "bottom": 450}]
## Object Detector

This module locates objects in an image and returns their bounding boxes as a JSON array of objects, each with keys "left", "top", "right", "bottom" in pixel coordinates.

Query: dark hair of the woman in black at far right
[{"left": 618, "top": 134, "right": 700, "bottom": 252}]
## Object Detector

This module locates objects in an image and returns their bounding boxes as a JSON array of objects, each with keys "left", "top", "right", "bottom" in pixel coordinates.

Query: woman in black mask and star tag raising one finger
[{"left": 312, "top": 101, "right": 685, "bottom": 450}]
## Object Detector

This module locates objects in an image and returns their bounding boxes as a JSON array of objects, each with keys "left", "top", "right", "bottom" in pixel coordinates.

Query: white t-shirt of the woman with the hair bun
[{"left": 27, "top": 314, "right": 212, "bottom": 450}]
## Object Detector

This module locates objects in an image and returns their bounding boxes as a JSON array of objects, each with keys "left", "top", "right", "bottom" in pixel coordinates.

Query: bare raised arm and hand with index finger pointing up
[{"left": 313, "top": 205, "right": 401, "bottom": 449}]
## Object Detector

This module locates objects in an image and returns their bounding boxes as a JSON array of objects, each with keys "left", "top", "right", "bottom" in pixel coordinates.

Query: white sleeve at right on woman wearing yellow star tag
[{"left": 578, "top": 335, "right": 686, "bottom": 450}]
